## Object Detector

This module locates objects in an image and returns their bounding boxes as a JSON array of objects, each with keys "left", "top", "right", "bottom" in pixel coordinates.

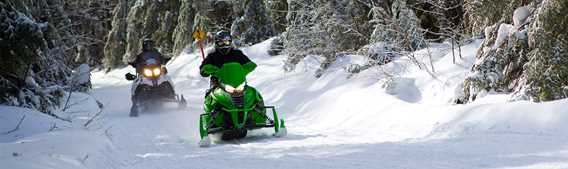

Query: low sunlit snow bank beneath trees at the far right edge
[{"left": 433, "top": 98, "right": 568, "bottom": 137}]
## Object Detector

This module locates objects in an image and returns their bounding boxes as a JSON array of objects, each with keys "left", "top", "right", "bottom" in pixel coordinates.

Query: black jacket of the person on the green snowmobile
[{"left": 199, "top": 49, "right": 251, "bottom": 77}]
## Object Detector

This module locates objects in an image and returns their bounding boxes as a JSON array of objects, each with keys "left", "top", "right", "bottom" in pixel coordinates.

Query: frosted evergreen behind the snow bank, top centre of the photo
[{"left": 284, "top": 0, "right": 367, "bottom": 76}]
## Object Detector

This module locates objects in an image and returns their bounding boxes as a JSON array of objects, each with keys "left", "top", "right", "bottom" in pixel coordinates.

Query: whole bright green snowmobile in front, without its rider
[{"left": 199, "top": 62, "right": 286, "bottom": 147}]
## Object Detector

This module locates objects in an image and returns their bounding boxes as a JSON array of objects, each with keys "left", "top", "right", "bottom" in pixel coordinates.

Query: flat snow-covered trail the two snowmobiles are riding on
[{"left": 89, "top": 84, "right": 568, "bottom": 169}]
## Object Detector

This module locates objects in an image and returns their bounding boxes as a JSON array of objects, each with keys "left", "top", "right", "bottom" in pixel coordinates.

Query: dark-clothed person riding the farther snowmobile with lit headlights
[{"left": 128, "top": 38, "right": 171, "bottom": 72}]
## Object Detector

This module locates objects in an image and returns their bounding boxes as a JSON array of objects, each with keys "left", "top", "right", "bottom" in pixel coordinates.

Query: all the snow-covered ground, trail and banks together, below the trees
[{"left": 0, "top": 40, "right": 568, "bottom": 169}]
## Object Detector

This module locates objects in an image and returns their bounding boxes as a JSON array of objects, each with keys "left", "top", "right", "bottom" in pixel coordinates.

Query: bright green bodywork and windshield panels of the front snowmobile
[{"left": 199, "top": 62, "right": 284, "bottom": 138}]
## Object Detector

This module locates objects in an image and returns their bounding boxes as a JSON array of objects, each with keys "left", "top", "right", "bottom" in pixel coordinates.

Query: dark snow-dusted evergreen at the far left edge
[{"left": 0, "top": 2, "right": 76, "bottom": 113}]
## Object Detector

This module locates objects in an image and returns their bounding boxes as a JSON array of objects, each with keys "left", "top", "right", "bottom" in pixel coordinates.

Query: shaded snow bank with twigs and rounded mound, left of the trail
[{"left": 0, "top": 92, "right": 114, "bottom": 169}]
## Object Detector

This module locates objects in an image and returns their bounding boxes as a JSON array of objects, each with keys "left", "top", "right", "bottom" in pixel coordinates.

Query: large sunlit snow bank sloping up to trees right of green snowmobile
[{"left": 237, "top": 37, "right": 568, "bottom": 146}]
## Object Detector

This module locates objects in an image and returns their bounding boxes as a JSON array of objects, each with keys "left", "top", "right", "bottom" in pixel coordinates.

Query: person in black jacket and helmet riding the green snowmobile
[{"left": 199, "top": 30, "right": 254, "bottom": 96}]
